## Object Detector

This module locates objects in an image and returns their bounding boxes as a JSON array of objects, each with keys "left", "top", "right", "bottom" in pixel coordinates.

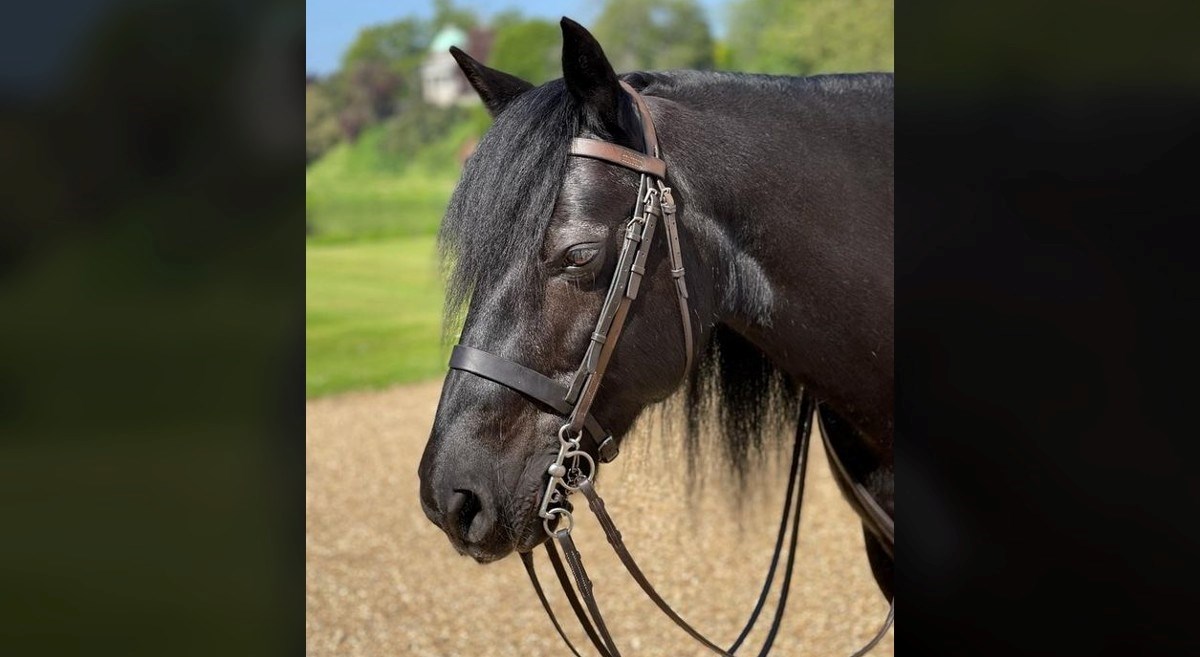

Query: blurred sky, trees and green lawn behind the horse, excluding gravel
[{"left": 305, "top": 0, "right": 894, "bottom": 398}]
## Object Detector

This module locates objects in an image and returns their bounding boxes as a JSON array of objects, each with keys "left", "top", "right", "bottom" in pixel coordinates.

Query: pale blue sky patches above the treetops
[{"left": 305, "top": 0, "right": 726, "bottom": 74}]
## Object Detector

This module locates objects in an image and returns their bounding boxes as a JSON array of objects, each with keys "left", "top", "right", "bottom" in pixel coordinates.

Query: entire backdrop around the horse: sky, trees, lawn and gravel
[{"left": 305, "top": 0, "right": 894, "bottom": 656}]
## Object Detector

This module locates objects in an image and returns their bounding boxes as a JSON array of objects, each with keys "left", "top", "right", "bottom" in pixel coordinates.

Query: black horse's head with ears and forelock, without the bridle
[{"left": 419, "top": 18, "right": 712, "bottom": 562}]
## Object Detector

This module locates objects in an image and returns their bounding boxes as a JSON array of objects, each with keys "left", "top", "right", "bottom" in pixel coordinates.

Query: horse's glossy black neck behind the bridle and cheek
[{"left": 660, "top": 75, "right": 894, "bottom": 446}]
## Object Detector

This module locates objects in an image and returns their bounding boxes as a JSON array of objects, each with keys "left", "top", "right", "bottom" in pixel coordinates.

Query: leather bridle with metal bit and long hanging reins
[{"left": 450, "top": 80, "right": 895, "bottom": 657}]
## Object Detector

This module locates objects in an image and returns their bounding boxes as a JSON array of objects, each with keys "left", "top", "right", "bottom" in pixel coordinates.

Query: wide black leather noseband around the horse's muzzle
[{"left": 450, "top": 344, "right": 617, "bottom": 463}]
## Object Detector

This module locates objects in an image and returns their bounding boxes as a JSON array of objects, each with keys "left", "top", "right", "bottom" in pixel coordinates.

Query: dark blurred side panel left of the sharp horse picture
[{"left": 0, "top": 0, "right": 305, "bottom": 656}]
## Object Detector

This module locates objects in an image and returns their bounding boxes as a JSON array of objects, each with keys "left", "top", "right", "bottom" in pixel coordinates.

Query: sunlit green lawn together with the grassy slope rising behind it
[{"left": 305, "top": 122, "right": 478, "bottom": 397}]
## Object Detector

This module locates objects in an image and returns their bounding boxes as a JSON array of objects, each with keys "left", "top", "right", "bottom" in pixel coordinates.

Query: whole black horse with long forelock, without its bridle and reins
[{"left": 420, "top": 18, "right": 895, "bottom": 599}]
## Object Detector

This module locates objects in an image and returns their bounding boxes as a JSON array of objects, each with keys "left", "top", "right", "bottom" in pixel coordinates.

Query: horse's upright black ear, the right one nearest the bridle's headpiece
[{"left": 560, "top": 16, "right": 622, "bottom": 126}]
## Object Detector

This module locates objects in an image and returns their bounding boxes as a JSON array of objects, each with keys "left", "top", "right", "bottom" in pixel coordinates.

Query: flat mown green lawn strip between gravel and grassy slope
[{"left": 305, "top": 235, "right": 449, "bottom": 397}]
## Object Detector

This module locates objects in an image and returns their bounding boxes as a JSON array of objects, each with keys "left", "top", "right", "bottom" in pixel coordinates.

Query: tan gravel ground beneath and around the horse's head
[{"left": 305, "top": 381, "right": 895, "bottom": 656}]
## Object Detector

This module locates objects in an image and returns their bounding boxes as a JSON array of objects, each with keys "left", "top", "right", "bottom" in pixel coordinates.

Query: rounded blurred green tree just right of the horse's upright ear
[{"left": 592, "top": 0, "right": 713, "bottom": 73}]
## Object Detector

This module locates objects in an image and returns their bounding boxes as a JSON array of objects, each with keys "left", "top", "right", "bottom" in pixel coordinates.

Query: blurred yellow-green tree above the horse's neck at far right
[{"left": 728, "top": 0, "right": 895, "bottom": 74}]
